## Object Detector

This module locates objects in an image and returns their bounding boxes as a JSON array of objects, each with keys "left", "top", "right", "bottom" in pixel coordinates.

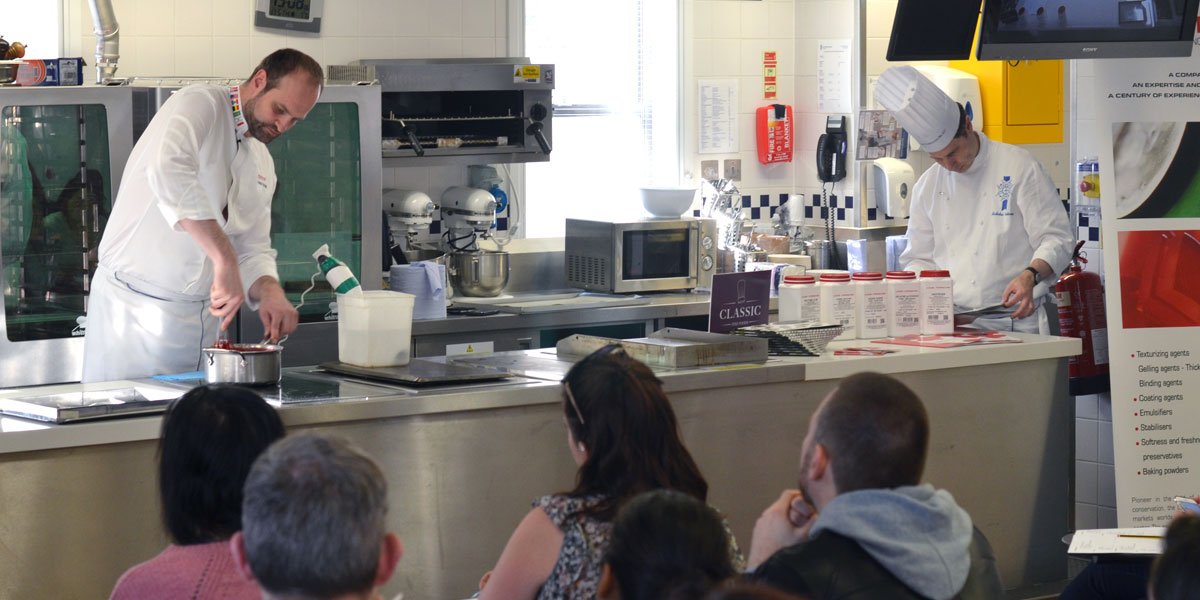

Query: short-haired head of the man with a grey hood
[{"left": 814, "top": 373, "right": 929, "bottom": 493}]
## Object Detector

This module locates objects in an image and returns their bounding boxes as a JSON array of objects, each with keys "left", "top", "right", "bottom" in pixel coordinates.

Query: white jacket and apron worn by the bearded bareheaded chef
[{"left": 83, "top": 85, "right": 278, "bottom": 382}]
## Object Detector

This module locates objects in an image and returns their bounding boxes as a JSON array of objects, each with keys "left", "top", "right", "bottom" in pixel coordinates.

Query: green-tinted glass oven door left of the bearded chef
[{"left": 0, "top": 104, "right": 113, "bottom": 341}]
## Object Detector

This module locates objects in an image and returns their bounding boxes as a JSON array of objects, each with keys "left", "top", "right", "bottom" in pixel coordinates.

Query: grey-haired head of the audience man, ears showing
[{"left": 230, "top": 433, "right": 402, "bottom": 600}]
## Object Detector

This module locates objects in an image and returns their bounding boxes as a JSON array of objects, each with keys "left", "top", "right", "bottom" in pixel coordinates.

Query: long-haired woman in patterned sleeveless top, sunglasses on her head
[{"left": 480, "top": 344, "right": 740, "bottom": 600}]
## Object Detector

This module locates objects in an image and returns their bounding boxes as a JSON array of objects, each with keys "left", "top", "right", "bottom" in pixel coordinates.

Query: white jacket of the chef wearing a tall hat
[{"left": 900, "top": 133, "right": 1074, "bottom": 332}]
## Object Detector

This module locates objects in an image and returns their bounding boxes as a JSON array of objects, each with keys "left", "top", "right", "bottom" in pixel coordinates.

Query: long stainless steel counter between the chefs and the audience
[{"left": 0, "top": 336, "right": 1079, "bottom": 600}]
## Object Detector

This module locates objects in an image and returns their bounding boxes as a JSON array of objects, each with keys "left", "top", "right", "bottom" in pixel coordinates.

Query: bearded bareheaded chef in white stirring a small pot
[{"left": 83, "top": 49, "right": 324, "bottom": 382}]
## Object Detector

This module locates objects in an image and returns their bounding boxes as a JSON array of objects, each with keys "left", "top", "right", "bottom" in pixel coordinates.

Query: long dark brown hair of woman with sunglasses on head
[{"left": 563, "top": 346, "right": 708, "bottom": 520}]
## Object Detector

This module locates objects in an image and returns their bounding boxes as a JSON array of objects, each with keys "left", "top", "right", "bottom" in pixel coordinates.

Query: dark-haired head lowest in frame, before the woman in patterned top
[{"left": 598, "top": 490, "right": 736, "bottom": 600}]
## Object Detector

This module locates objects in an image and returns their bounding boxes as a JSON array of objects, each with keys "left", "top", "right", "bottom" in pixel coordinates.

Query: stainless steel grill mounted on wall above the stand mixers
[{"left": 345, "top": 58, "right": 554, "bottom": 167}]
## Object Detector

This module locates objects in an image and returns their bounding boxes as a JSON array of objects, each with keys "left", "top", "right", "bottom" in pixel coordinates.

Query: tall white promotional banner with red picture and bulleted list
[{"left": 1093, "top": 58, "right": 1200, "bottom": 527}]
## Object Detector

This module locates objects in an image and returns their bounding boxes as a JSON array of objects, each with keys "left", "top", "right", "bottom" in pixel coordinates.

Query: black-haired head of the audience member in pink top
[{"left": 158, "top": 385, "right": 283, "bottom": 546}]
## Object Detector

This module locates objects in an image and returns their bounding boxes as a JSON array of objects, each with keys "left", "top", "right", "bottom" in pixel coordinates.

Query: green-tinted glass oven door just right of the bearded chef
[{"left": 271, "top": 102, "right": 362, "bottom": 322}]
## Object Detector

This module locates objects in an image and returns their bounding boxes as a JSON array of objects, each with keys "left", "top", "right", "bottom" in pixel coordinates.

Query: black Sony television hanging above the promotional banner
[{"left": 978, "top": 0, "right": 1200, "bottom": 60}]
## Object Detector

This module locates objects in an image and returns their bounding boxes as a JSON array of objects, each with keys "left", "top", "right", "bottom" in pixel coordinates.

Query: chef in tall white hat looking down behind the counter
[{"left": 875, "top": 66, "right": 1074, "bottom": 334}]
